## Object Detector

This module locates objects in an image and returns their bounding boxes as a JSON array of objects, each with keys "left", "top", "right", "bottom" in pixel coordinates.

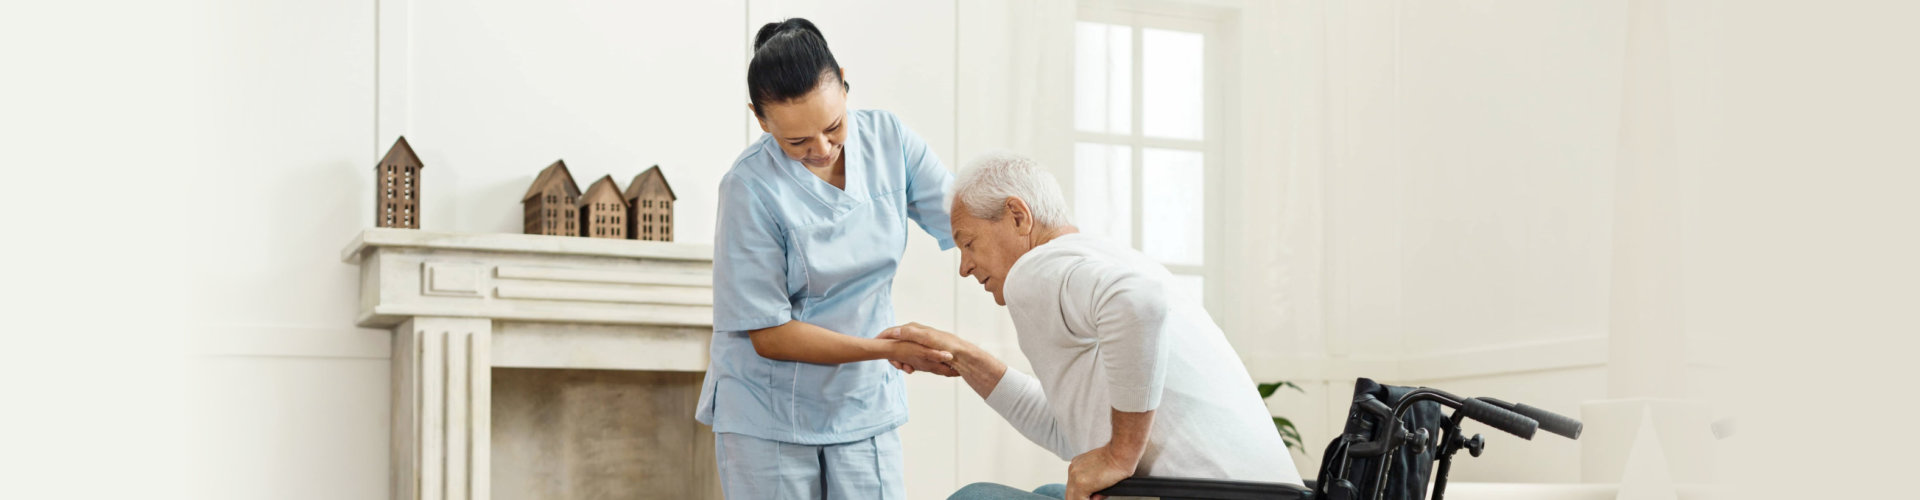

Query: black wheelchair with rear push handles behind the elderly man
[{"left": 1100, "top": 379, "right": 1582, "bottom": 500}]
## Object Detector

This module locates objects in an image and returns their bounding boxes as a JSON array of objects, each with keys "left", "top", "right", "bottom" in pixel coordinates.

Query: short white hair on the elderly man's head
[{"left": 954, "top": 152, "right": 1073, "bottom": 227}]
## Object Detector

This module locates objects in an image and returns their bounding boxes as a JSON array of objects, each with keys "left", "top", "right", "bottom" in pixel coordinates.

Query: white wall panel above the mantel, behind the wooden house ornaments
[{"left": 401, "top": 0, "right": 747, "bottom": 242}]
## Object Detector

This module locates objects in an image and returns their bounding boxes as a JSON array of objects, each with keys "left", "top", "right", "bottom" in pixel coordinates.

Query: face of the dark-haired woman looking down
[{"left": 760, "top": 79, "right": 847, "bottom": 169}]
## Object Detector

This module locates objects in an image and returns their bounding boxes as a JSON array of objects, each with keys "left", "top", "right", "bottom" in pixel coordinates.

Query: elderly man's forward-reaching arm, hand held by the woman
[{"left": 879, "top": 323, "right": 1073, "bottom": 460}]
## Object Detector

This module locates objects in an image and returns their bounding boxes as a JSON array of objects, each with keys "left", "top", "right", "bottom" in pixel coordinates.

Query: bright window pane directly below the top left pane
[{"left": 1073, "top": 142, "right": 1133, "bottom": 246}]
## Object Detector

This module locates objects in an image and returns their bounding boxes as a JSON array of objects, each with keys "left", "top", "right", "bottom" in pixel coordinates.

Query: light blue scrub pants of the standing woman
[{"left": 714, "top": 431, "right": 906, "bottom": 500}]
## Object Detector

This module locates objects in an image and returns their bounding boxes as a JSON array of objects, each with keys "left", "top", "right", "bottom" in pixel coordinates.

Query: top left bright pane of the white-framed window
[{"left": 1073, "top": 23, "right": 1133, "bottom": 135}]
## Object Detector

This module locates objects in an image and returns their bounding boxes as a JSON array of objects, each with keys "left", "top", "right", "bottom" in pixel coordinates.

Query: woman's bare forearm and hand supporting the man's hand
[{"left": 747, "top": 319, "right": 956, "bottom": 377}]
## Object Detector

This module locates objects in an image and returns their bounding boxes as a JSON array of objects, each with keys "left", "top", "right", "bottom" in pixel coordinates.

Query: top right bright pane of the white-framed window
[{"left": 1140, "top": 29, "right": 1206, "bottom": 140}]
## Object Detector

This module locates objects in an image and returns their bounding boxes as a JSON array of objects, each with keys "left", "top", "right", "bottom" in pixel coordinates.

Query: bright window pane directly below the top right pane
[{"left": 1140, "top": 148, "right": 1206, "bottom": 265}]
